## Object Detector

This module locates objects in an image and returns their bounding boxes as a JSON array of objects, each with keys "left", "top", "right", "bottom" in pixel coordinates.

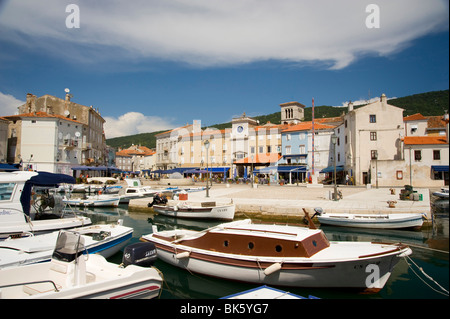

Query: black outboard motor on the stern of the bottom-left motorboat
[{"left": 122, "top": 242, "right": 158, "bottom": 267}]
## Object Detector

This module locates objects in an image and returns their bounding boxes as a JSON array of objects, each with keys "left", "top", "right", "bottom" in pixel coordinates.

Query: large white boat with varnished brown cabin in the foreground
[{"left": 141, "top": 219, "right": 412, "bottom": 292}]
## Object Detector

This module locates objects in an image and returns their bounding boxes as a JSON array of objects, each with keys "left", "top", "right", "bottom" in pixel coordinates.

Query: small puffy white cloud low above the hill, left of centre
[{"left": 104, "top": 112, "right": 178, "bottom": 138}]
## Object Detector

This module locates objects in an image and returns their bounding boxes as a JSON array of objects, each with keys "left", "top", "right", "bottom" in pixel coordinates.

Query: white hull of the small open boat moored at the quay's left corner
[{"left": 153, "top": 205, "right": 235, "bottom": 220}]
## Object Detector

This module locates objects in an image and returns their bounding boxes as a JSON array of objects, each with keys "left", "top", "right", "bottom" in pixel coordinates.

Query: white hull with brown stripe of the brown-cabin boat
[{"left": 143, "top": 237, "right": 411, "bottom": 292}]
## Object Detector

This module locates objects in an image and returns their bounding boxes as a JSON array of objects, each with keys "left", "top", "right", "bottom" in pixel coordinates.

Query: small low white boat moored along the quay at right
[{"left": 317, "top": 213, "right": 426, "bottom": 229}]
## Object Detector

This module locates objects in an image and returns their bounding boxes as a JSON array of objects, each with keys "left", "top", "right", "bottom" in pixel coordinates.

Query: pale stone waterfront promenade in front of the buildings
[{"left": 129, "top": 184, "right": 431, "bottom": 224}]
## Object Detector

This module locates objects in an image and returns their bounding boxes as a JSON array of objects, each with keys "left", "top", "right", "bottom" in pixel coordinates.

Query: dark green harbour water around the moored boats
[{"left": 81, "top": 201, "right": 449, "bottom": 299}]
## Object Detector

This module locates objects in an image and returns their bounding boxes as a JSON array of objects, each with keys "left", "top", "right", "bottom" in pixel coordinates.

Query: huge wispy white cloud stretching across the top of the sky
[{"left": 0, "top": 0, "right": 449, "bottom": 69}]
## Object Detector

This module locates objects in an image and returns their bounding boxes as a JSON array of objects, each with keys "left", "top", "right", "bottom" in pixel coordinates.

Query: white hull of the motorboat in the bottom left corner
[{"left": 0, "top": 255, "right": 162, "bottom": 299}]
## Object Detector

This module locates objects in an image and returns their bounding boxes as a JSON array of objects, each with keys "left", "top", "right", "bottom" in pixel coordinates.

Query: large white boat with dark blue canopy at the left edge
[{"left": 0, "top": 171, "right": 91, "bottom": 239}]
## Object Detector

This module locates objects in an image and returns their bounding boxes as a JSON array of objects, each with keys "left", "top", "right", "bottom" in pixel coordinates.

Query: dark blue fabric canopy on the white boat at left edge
[{"left": 20, "top": 172, "right": 75, "bottom": 216}]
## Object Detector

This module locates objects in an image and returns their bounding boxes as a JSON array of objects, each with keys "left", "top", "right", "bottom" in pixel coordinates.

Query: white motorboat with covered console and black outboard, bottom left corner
[{"left": 0, "top": 231, "right": 162, "bottom": 299}]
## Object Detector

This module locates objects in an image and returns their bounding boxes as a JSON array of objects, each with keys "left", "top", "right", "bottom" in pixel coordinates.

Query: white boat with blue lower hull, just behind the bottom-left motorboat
[{"left": 0, "top": 220, "right": 133, "bottom": 269}]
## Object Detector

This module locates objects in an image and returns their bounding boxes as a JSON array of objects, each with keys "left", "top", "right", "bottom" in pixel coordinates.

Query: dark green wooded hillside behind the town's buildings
[{"left": 106, "top": 90, "right": 449, "bottom": 149}]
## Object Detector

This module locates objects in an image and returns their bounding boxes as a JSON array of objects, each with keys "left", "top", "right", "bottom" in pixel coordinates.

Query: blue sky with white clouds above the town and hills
[{"left": 0, "top": 0, "right": 449, "bottom": 138}]
